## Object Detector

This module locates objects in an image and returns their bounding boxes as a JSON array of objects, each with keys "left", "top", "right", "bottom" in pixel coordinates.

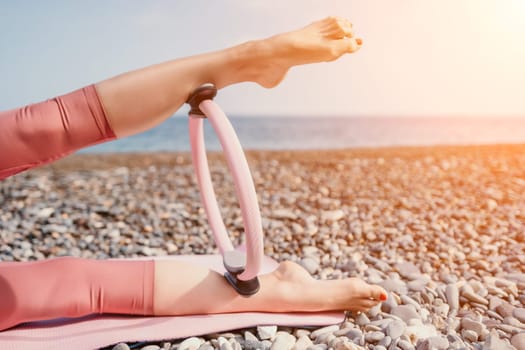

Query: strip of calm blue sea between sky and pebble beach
[{"left": 82, "top": 116, "right": 525, "bottom": 153}]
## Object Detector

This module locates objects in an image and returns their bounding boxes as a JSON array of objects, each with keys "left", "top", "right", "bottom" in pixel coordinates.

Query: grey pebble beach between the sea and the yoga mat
[{"left": 0, "top": 145, "right": 525, "bottom": 350}]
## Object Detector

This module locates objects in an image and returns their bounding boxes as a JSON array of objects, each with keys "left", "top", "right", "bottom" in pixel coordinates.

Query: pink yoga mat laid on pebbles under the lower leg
[{"left": 0, "top": 255, "right": 344, "bottom": 350}]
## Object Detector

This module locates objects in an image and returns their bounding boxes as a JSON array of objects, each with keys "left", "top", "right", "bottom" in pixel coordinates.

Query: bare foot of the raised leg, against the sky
[{"left": 238, "top": 17, "right": 362, "bottom": 88}]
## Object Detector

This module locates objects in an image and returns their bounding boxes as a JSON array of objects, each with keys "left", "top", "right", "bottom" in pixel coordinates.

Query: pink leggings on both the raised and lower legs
[{"left": 0, "top": 85, "right": 154, "bottom": 330}]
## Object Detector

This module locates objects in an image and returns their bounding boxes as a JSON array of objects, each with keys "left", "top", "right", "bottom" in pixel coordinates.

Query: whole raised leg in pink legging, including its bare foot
[{"left": 0, "top": 18, "right": 361, "bottom": 179}]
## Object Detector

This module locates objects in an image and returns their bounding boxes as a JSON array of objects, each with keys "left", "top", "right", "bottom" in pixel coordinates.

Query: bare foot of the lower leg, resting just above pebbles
[{"left": 264, "top": 261, "right": 387, "bottom": 312}]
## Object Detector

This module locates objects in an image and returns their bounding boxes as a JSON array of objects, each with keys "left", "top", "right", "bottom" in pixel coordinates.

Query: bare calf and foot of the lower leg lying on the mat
[{"left": 154, "top": 260, "right": 387, "bottom": 315}]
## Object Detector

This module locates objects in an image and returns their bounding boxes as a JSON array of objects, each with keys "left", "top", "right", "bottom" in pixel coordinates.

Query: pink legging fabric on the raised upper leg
[{"left": 0, "top": 85, "right": 115, "bottom": 179}]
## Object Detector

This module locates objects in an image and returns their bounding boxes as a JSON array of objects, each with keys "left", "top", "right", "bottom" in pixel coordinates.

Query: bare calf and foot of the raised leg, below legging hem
[{"left": 96, "top": 17, "right": 361, "bottom": 137}]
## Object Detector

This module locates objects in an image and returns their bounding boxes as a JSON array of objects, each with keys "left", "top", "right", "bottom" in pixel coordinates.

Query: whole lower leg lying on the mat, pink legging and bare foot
[{"left": 0, "top": 258, "right": 386, "bottom": 330}]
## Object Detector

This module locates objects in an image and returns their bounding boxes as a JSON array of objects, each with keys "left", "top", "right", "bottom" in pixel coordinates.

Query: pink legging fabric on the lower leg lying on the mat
[{"left": 0, "top": 257, "right": 155, "bottom": 331}]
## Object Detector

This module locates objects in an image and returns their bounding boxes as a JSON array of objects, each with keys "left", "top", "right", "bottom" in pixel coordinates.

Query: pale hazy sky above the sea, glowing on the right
[{"left": 0, "top": 0, "right": 525, "bottom": 117}]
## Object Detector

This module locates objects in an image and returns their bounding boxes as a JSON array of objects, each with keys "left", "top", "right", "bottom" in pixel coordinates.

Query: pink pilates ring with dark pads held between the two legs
[{"left": 186, "top": 84, "right": 264, "bottom": 296}]
